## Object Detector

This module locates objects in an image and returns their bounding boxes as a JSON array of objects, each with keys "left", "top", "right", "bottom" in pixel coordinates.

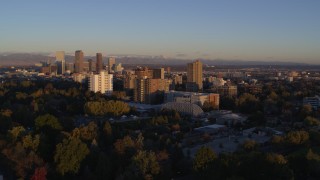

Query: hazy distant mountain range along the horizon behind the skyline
[{"left": 0, "top": 53, "right": 316, "bottom": 66}]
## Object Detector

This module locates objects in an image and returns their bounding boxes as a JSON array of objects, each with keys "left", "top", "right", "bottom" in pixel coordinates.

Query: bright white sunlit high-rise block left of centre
[{"left": 88, "top": 71, "right": 113, "bottom": 95}]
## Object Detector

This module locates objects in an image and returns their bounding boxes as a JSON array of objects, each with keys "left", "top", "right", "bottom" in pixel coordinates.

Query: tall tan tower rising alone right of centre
[{"left": 186, "top": 60, "right": 203, "bottom": 92}]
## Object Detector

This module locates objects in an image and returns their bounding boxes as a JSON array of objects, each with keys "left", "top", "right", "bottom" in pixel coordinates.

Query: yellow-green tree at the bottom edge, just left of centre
[{"left": 133, "top": 151, "right": 160, "bottom": 179}]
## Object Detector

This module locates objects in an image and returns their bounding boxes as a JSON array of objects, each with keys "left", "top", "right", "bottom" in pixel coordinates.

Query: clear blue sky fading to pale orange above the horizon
[{"left": 0, "top": 0, "right": 320, "bottom": 64}]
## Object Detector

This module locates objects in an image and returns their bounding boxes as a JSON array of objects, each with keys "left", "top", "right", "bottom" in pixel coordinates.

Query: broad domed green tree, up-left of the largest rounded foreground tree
[{"left": 35, "top": 114, "right": 62, "bottom": 130}]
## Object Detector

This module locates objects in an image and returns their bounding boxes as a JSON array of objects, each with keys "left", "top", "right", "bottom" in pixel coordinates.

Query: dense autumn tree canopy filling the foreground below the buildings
[{"left": 0, "top": 79, "right": 320, "bottom": 180}]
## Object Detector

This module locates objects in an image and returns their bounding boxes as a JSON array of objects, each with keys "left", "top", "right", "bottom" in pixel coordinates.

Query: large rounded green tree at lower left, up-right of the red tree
[{"left": 54, "top": 137, "right": 89, "bottom": 175}]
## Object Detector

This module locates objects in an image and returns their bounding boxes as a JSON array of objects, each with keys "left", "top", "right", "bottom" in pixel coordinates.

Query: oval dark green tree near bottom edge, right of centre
[{"left": 193, "top": 146, "right": 216, "bottom": 172}]
